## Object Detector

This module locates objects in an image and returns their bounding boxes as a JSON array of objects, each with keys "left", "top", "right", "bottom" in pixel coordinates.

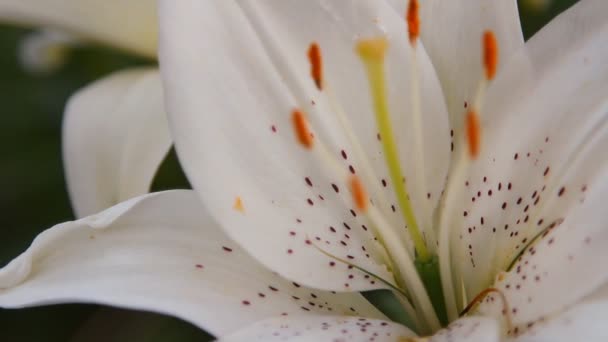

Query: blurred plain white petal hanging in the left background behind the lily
[{"left": 63, "top": 69, "right": 171, "bottom": 217}]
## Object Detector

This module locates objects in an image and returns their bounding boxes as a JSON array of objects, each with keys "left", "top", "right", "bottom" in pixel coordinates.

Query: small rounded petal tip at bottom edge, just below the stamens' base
[{"left": 429, "top": 317, "right": 501, "bottom": 342}]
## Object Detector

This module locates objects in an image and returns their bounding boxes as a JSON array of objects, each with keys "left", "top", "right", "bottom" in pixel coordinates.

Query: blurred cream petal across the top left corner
[{"left": 0, "top": 0, "right": 158, "bottom": 57}]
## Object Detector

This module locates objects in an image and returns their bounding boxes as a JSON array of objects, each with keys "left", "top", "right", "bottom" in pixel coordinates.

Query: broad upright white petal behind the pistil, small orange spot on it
[{"left": 160, "top": 0, "right": 449, "bottom": 290}]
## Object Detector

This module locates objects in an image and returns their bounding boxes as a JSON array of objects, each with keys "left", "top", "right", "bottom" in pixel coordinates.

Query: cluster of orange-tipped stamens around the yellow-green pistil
[{"left": 292, "top": 0, "right": 498, "bottom": 332}]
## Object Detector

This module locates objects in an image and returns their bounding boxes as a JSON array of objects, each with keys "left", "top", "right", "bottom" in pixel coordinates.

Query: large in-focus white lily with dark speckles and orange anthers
[{"left": 0, "top": 0, "right": 608, "bottom": 341}]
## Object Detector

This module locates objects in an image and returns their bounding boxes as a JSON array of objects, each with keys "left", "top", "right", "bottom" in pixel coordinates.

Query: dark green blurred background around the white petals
[{"left": 0, "top": 0, "right": 576, "bottom": 342}]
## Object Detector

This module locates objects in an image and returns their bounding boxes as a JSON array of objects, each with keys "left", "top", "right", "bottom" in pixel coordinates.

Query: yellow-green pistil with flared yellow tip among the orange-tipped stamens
[{"left": 356, "top": 38, "right": 431, "bottom": 262}]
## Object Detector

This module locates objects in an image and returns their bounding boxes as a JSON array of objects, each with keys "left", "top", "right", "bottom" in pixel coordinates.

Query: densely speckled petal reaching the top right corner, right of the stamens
[{"left": 444, "top": 0, "right": 608, "bottom": 298}]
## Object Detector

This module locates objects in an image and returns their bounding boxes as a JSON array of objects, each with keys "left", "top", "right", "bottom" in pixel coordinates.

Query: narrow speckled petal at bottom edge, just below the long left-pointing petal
[{"left": 219, "top": 316, "right": 415, "bottom": 342}]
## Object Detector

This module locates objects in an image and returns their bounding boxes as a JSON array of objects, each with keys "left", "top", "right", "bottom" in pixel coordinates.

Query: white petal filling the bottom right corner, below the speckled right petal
[{"left": 515, "top": 300, "right": 608, "bottom": 342}]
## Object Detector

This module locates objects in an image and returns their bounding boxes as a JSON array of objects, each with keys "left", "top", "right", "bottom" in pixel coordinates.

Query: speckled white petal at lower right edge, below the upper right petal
[{"left": 481, "top": 175, "right": 608, "bottom": 326}]
